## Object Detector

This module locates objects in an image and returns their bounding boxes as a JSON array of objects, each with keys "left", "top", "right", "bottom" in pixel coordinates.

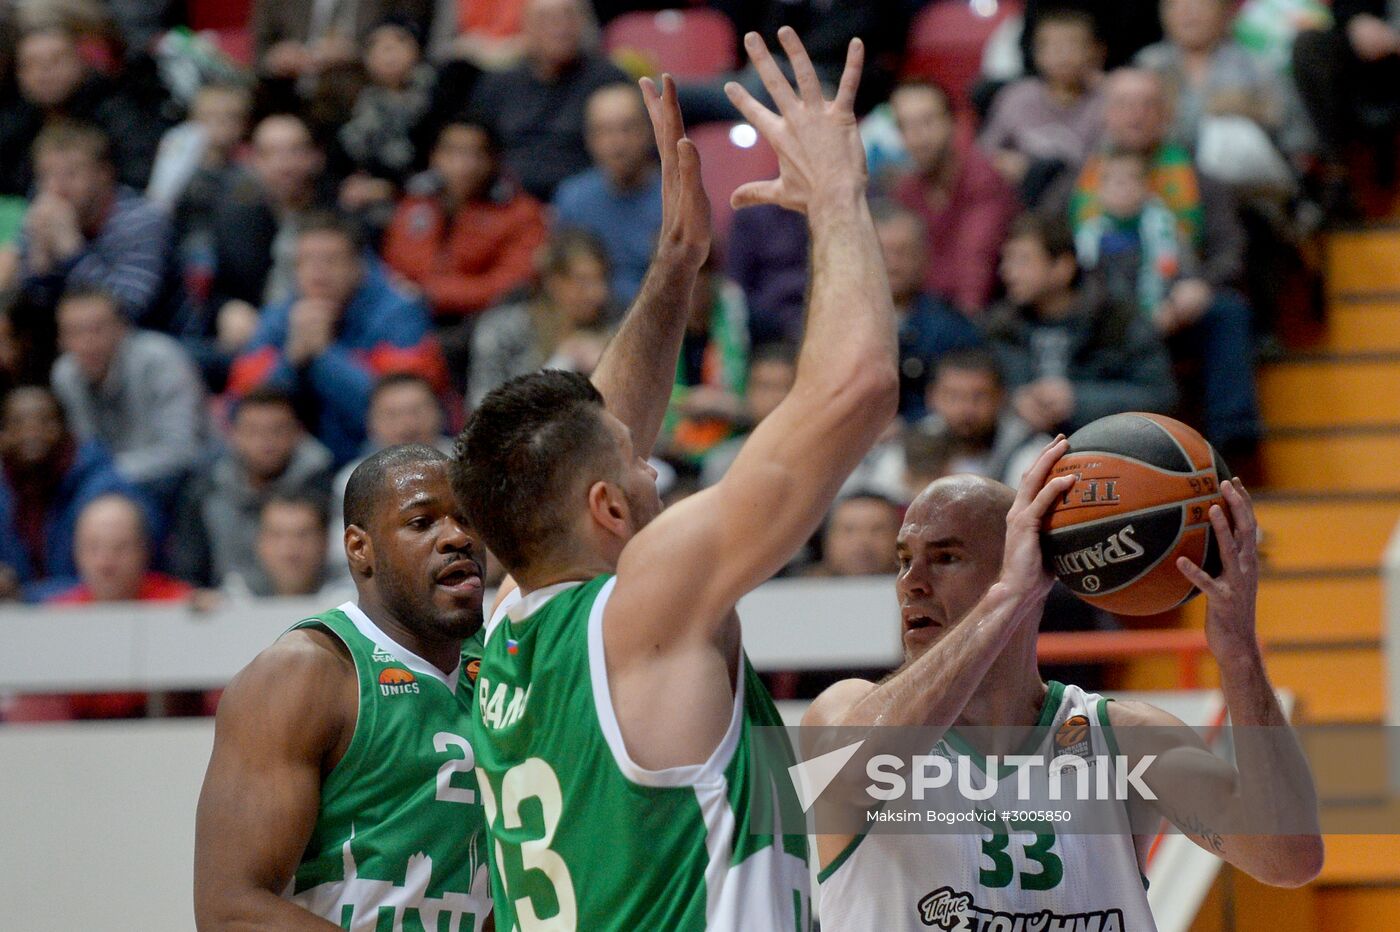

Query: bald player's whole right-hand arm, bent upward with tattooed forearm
[{"left": 1109, "top": 480, "right": 1323, "bottom": 887}]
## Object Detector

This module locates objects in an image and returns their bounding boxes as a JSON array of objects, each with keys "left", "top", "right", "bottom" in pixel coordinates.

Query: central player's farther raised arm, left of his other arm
[{"left": 592, "top": 74, "right": 710, "bottom": 456}]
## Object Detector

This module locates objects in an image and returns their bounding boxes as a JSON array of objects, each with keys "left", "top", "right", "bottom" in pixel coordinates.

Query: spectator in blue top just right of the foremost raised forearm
[{"left": 875, "top": 203, "right": 981, "bottom": 423}]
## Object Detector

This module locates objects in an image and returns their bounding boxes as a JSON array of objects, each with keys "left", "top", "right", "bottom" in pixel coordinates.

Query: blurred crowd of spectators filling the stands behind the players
[{"left": 0, "top": 0, "right": 1400, "bottom": 712}]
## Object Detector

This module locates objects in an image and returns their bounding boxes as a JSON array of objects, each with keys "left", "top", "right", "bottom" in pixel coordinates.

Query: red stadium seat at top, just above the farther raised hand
[{"left": 603, "top": 8, "right": 738, "bottom": 78}]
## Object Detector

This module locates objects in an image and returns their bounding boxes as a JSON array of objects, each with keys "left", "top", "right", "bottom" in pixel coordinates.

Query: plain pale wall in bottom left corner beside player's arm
[{"left": 0, "top": 719, "right": 214, "bottom": 932}]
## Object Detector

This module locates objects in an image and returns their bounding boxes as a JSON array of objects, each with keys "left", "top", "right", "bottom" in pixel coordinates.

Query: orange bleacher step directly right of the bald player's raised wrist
[{"left": 1182, "top": 572, "right": 1385, "bottom": 645}]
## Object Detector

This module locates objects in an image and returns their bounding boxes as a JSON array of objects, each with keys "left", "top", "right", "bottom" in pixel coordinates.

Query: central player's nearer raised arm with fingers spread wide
[{"left": 608, "top": 28, "right": 899, "bottom": 651}]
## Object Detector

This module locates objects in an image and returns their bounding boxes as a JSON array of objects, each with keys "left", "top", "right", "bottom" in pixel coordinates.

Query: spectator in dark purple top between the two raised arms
[{"left": 727, "top": 204, "right": 808, "bottom": 346}]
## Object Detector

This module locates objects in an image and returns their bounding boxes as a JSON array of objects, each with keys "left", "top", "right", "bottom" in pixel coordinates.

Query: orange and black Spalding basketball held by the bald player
[{"left": 1042, "top": 413, "right": 1231, "bottom": 614}]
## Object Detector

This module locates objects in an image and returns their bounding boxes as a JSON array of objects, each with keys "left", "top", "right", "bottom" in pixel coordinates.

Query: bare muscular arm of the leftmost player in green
[{"left": 195, "top": 631, "right": 357, "bottom": 932}]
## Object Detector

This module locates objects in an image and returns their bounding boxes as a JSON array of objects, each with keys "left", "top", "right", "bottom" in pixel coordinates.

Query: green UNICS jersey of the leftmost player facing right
[{"left": 284, "top": 602, "right": 491, "bottom": 932}]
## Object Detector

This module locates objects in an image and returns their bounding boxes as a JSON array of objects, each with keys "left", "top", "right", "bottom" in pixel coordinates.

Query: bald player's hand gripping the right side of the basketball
[{"left": 1176, "top": 479, "right": 1259, "bottom": 663}]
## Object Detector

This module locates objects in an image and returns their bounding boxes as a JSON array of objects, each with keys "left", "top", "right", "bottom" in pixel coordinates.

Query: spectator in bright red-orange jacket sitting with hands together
[{"left": 384, "top": 122, "right": 549, "bottom": 375}]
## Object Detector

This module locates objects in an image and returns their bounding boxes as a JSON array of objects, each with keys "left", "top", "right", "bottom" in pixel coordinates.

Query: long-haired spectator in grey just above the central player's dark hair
[{"left": 468, "top": 230, "right": 617, "bottom": 406}]
